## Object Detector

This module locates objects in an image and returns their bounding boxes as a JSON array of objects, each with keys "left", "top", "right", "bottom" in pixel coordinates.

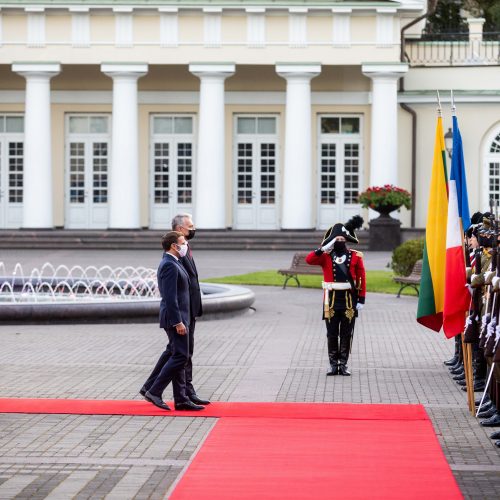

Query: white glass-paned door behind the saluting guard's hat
[{"left": 317, "top": 115, "right": 363, "bottom": 229}]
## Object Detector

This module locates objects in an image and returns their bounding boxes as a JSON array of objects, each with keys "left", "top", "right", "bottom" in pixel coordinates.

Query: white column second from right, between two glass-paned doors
[{"left": 276, "top": 64, "right": 321, "bottom": 229}]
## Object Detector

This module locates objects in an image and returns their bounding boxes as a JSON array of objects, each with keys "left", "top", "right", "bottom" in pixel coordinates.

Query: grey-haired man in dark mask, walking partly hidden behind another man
[{"left": 140, "top": 214, "right": 210, "bottom": 409}]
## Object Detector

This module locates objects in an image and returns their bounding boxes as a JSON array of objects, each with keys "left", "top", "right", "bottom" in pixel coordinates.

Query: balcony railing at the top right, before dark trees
[{"left": 404, "top": 32, "right": 500, "bottom": 67}]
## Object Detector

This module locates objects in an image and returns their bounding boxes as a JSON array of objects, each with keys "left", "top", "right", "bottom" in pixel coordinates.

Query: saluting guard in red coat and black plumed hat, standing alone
[{"left": 306, "top": 216, "right": 366, "bottom": 376}]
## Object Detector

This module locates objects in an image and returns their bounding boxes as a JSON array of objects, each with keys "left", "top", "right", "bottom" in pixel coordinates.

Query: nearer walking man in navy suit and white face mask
[{"left": 141, "top": 231, "right": 204, "bottom": 411}]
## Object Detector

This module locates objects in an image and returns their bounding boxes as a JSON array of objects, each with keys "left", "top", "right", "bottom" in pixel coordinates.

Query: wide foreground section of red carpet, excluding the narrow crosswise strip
[{"left": 170, "top": 414, "right": 462, "bottom": 500}]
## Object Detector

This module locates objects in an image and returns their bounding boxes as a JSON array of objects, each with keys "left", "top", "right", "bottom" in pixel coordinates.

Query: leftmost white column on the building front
[{"left": 12, "top": 63, "right": 61, "bottom": 229}]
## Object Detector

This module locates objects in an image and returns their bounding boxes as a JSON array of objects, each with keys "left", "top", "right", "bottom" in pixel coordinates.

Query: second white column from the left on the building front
[{"left": 101, "top": 64, "right": 148, "bottom": 229}]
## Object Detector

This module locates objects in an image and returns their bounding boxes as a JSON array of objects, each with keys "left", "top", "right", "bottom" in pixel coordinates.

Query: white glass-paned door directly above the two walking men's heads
[{"left": 149, "top": 115, "right": 194, "bottom": 230}]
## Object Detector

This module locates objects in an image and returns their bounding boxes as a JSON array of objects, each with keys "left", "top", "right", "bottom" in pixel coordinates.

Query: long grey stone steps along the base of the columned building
[{"left": 0, "top": 229, "right": 368, "bottom": 250}]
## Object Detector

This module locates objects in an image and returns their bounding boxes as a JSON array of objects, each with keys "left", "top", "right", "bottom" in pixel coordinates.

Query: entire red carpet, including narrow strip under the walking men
[{"left": 0, "top": 398, "right": 462, "bottom": 500}]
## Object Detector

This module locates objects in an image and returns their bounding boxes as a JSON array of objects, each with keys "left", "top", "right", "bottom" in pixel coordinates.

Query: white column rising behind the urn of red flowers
[{"left": 362, "top": 63, "right": 408, "bottom": 186}]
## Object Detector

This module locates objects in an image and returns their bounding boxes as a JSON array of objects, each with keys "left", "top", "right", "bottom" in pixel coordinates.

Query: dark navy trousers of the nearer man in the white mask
[{"left": 144, "top": 328, "right": 189, "bottom": 403}]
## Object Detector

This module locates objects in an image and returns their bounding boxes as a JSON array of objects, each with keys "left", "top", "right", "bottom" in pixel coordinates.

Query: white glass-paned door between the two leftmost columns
[{"left": 65, "top": 115, "right": 110, "bottom": 229}]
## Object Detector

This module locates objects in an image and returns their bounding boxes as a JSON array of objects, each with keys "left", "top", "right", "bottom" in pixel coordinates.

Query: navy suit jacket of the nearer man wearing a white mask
[{"left": 157, "top": 253, "right": 191, "bottom": 328}]
